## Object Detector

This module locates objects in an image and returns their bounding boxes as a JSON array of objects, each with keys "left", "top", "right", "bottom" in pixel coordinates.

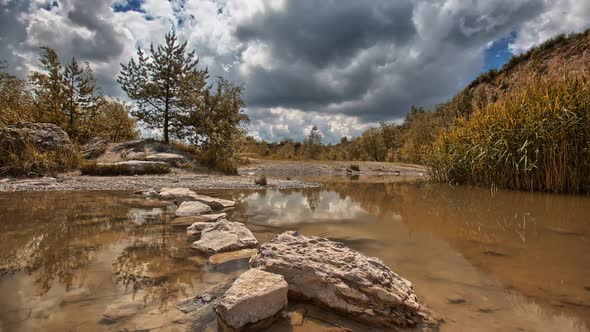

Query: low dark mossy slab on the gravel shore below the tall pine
[{"left": 81, "top": 160, "right": 170, "bottom": 176}]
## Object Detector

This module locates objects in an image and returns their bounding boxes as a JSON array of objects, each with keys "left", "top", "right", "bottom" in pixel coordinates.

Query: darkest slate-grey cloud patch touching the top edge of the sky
[{"left": 236, "top": 0, "right": 415, "bottom": 67}]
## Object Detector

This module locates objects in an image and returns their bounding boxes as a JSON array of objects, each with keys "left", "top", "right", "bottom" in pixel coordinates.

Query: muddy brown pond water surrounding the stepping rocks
[{"left": 0, "top": 179, "right": 590, "bottom": 332}]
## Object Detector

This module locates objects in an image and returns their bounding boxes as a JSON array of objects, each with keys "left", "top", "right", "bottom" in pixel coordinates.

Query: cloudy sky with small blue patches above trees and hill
[{"left": 0, "top": 0, "right": 590, "bottom": 142}]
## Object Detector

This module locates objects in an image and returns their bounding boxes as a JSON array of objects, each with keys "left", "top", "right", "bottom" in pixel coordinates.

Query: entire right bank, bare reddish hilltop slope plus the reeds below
[{"left": 424, "top": 30, "right": 590, "bottom": 193}]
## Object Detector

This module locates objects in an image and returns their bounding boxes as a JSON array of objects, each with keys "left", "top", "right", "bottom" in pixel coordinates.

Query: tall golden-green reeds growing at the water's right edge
[{"left": 423, "top": 76, "right": 590, "bottom": 193}]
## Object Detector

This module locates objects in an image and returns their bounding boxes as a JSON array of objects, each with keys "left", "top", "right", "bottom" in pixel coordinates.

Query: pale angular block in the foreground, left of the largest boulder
[{"left": 215, "top": 269, "right": 288, "bottom": 331}]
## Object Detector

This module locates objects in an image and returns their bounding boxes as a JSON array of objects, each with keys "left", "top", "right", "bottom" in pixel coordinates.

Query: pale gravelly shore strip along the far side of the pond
[{"left": 0, "top": 160, "right": 425, "bottom": 192}]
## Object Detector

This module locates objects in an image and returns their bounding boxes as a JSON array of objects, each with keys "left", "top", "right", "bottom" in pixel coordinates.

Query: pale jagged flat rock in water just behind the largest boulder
[{"left": 187, "top": 219, "right": 258, "bottom": 254}]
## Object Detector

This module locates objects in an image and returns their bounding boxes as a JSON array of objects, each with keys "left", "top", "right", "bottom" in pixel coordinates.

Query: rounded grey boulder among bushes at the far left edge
[{"left": 0, "top": 122, "right": 75, "bottom": 153}]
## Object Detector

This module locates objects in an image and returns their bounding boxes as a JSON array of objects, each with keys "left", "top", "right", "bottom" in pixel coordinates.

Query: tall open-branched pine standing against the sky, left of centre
[{"left": 117, "top": 31, "right": 207, "bottom": 143}]
